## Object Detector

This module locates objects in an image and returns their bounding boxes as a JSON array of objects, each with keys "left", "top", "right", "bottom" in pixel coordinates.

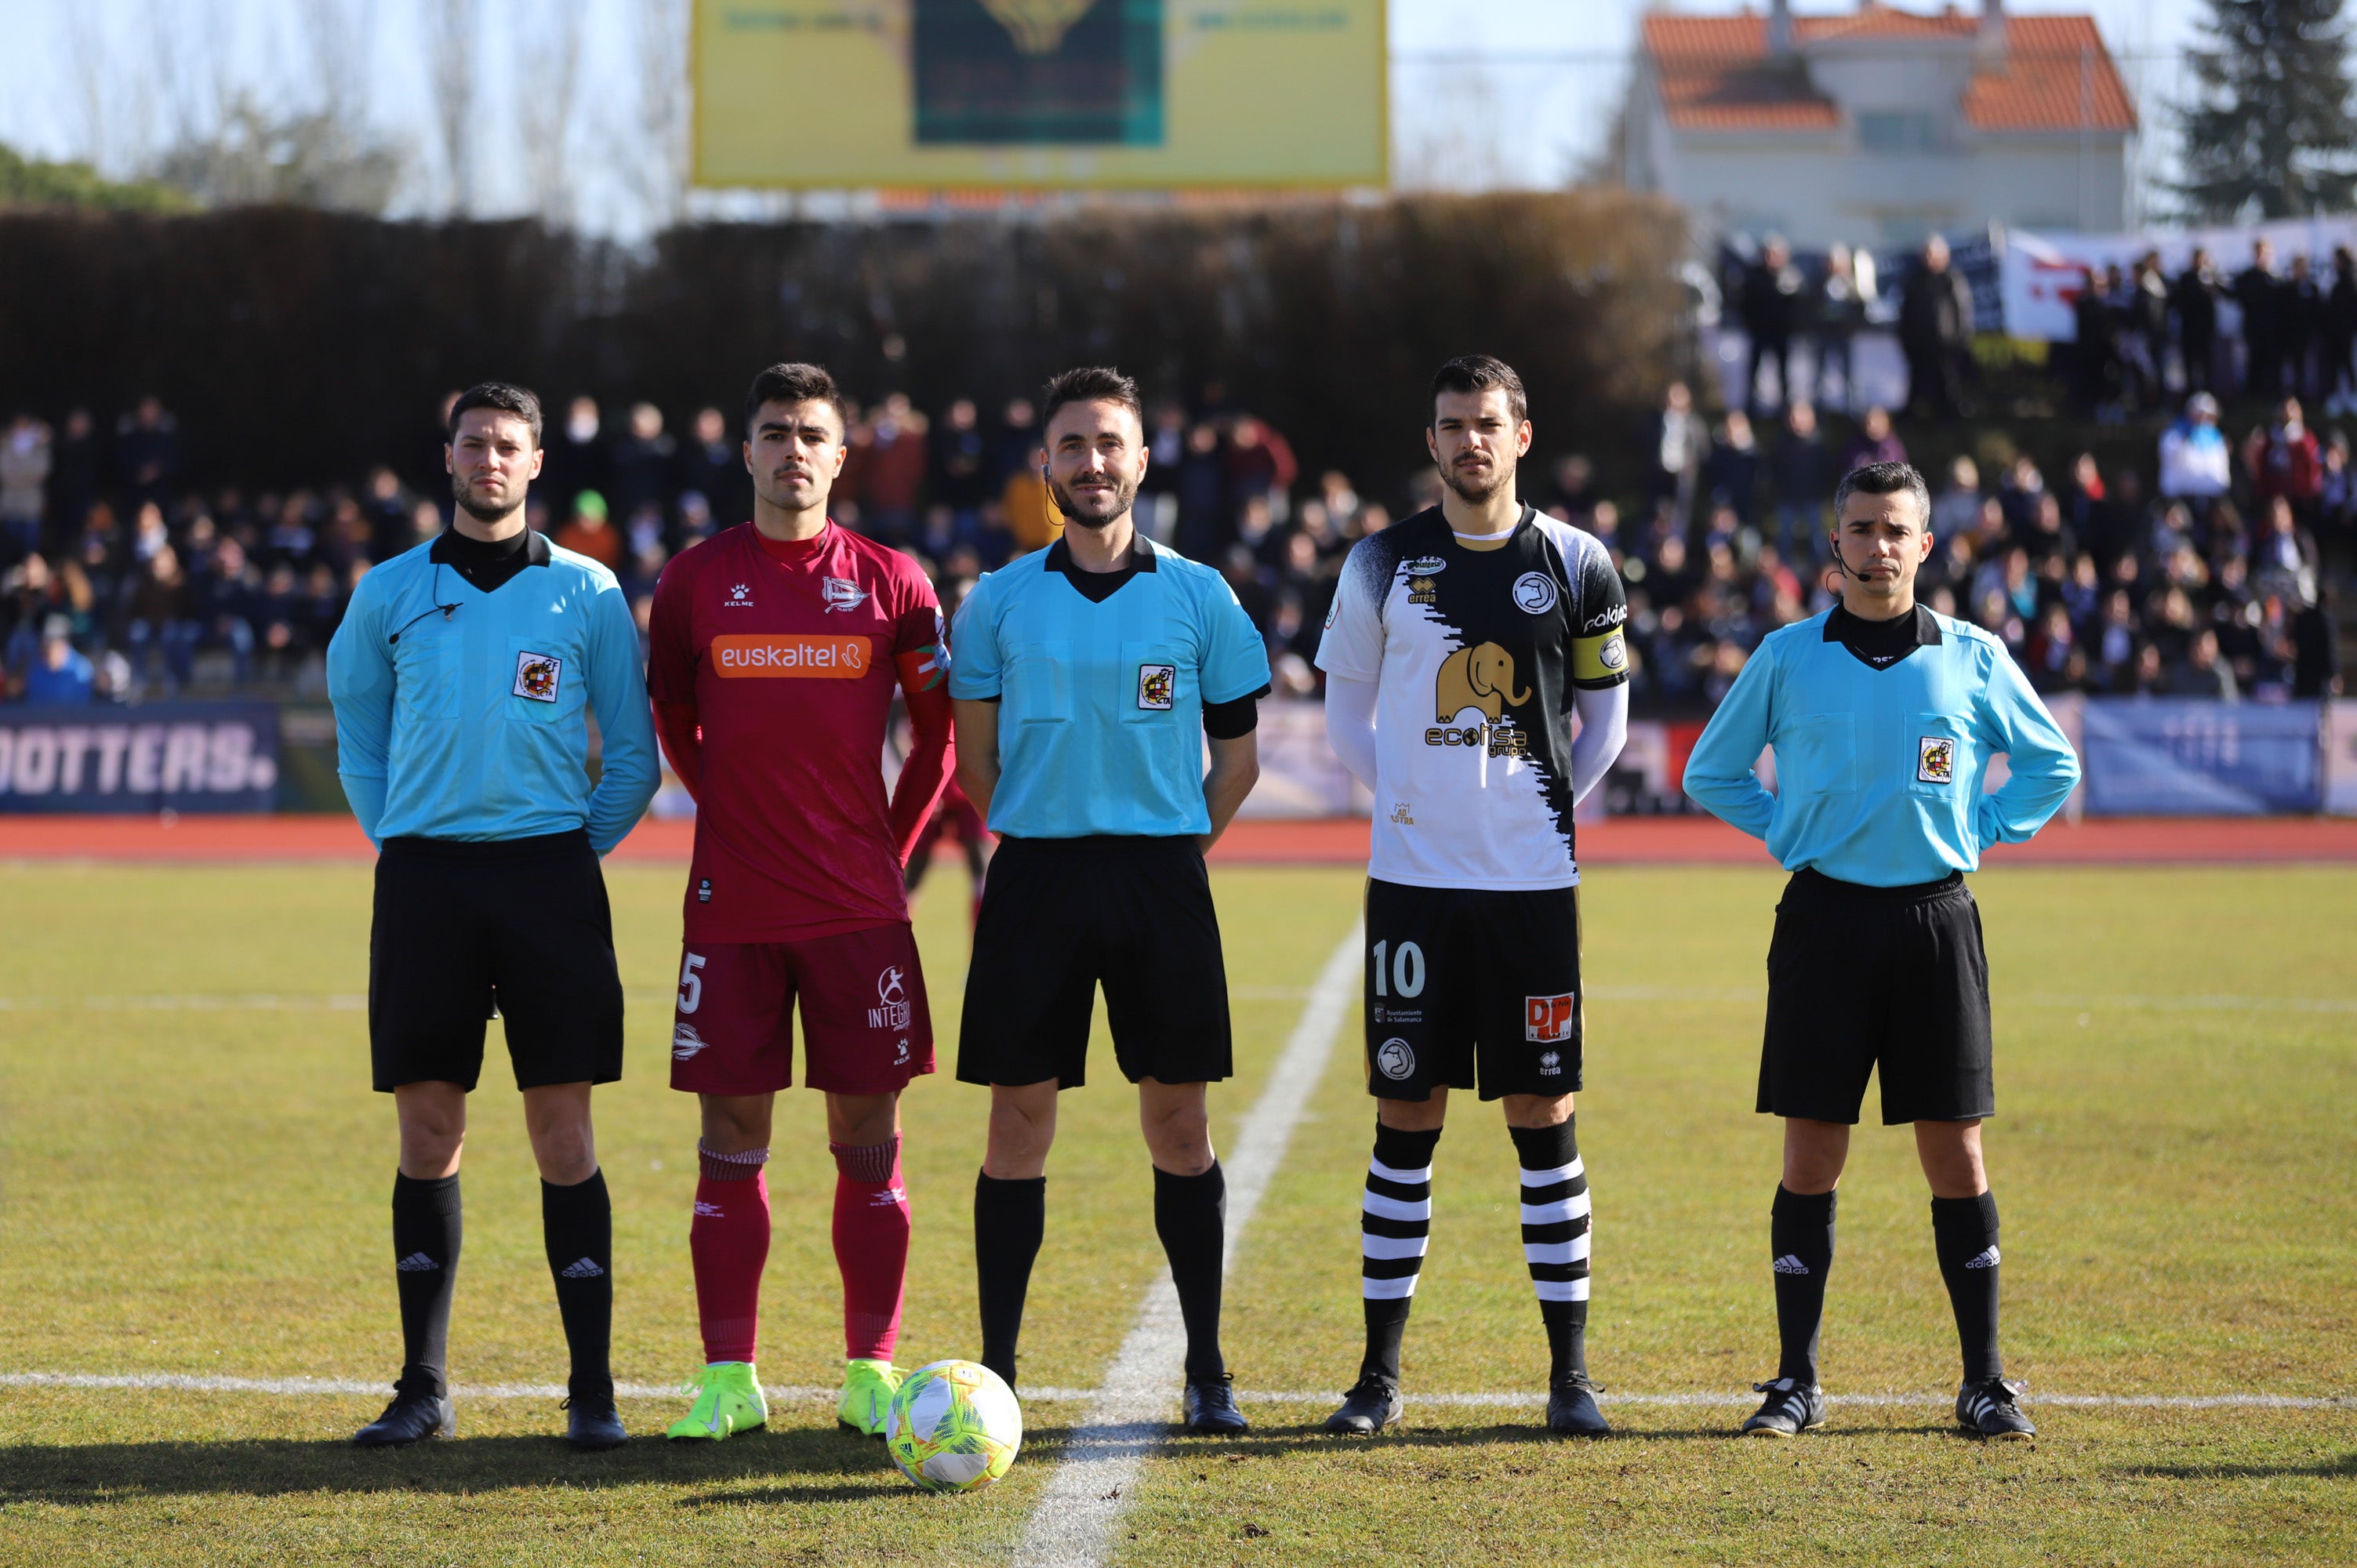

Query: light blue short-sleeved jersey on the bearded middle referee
[{"left": 950, "top": 538, "right": 1268, "bottom": 840}]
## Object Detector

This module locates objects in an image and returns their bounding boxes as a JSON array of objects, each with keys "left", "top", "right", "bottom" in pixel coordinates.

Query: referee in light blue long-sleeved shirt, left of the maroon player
[{"left": 328, "top": 382, "right": 656, "bottom": 1448}]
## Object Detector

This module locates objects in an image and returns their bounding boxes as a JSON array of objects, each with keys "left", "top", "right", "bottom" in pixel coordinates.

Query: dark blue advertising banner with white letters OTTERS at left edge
[{"left": 0, "top": 702, "right": 278, "bottom": 811}]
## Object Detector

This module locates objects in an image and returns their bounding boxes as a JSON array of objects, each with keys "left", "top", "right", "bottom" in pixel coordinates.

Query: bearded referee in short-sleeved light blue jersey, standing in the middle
[{"left": 950, "top": 370, "right": 1268, "bottom": 1432}]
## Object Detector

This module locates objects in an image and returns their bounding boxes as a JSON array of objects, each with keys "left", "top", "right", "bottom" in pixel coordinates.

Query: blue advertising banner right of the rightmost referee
[{"left": 2079, "top": 698, "right": 2324, "bottom": 816}]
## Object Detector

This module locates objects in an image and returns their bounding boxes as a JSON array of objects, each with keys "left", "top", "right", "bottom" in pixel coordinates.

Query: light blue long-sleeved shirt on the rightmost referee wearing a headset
[{"left": 1685, "top": 611, "right": 2079, "bottom": 887}]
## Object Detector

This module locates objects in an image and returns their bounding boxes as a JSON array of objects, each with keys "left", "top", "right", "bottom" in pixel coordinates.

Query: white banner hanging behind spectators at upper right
[{"left": 1996, "top": 217, "right": 2357, "bottom": 342}]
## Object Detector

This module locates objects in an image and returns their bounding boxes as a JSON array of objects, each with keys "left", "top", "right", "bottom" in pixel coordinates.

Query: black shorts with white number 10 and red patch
[{"left": 1367, "top": 877, "right": 1586, "bottom": 1102}]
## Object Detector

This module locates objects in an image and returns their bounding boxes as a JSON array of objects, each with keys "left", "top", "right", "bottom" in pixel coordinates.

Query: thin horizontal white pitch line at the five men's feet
[{"left": 0, "top": 1372, "right": 2357, "bottom": 1410}]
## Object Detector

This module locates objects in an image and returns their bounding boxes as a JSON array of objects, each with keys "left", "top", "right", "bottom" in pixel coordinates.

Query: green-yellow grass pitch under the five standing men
[{"left": 0, "top": 866, "right": 2357, "bottom": 1563}]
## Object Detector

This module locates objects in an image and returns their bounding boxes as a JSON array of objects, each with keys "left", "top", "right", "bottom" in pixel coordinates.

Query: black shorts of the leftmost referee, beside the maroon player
[{"left": 368, "top": 830, "right": 623, "bottom": 1091}]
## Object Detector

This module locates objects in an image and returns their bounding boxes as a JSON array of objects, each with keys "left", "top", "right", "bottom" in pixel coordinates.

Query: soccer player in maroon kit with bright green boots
[{"left": 648, "top": 365, "right": 950, "bottom": 1439}]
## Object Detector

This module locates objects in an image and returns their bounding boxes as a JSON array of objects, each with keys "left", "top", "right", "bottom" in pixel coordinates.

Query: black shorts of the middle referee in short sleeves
[{"left": 957, "top": 835, "right": 1235, "bottom": 1089}]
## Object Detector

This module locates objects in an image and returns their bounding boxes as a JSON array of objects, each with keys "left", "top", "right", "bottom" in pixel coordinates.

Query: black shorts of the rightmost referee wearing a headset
[{"left": 1758, "top": 870, "right": 1996, "bottom": 1127}]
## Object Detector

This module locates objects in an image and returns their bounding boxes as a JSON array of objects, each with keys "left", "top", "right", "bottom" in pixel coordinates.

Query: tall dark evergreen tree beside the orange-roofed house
[{"left": 2176, "top": 0, "right": 2357, "bottom": 222}]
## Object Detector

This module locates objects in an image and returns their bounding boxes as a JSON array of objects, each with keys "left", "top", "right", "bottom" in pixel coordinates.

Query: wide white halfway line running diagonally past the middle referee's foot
[{"left": 1016, "top": 924, "right": 1364, "bottom": 1568}]
